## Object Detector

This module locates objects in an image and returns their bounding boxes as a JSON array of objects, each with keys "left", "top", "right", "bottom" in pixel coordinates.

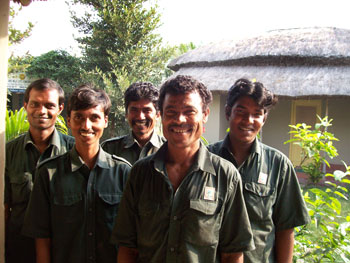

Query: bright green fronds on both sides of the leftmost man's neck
[{"left": 5, "top": 107, "right": 68, "bottom": 142}]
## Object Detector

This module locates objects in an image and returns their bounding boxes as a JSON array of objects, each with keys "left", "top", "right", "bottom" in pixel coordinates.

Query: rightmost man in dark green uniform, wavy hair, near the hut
[{"left": 209, "top": 79, "right": 310, "bottom": 263}]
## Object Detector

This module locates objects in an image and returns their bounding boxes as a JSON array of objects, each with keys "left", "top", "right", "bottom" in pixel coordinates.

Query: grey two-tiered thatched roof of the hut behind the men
[{"left": 168, "top": 28, "right": 350, "bottom": 97}]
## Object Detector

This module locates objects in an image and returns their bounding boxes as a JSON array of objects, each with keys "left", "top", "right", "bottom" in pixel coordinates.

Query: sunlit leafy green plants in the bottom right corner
[{"left": 294, "top": 165, "right": 350, "bottom": 263}]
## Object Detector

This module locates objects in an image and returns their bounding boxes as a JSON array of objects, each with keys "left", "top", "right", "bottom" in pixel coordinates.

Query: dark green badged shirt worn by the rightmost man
[{"left": 209, "top": 135, "right": 310, "bottom": 263}]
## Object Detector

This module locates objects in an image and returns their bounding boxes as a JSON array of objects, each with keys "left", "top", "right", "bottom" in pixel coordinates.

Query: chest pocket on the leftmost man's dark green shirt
[{"left": 9, "top": 172, "right": 33, "bottom": 205}]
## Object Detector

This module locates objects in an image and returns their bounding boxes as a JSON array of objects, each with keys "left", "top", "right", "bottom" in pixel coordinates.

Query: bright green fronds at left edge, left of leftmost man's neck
[{"left": 5, "top": 108, "right": 29, "bottom": 142}]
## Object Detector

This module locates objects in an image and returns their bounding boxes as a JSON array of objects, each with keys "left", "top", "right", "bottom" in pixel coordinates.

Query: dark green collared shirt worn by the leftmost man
[{"left": 5, "top": 129, "right": 74, "bottom": 233}]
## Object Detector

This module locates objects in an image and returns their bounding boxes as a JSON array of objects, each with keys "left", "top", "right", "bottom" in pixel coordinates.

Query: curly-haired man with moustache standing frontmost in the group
[{"left": 112, "top": 75, "right": 254, "bottom": 263}]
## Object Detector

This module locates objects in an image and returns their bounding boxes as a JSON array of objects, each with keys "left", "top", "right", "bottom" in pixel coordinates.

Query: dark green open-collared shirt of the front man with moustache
[{"left": 112, "top": 143, "right": 254, "bottom": 263}]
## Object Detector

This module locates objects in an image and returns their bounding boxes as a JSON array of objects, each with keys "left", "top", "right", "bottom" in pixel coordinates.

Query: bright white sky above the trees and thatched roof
[{"left": 10, "top": 0, "right": 350, "bottom": 56}]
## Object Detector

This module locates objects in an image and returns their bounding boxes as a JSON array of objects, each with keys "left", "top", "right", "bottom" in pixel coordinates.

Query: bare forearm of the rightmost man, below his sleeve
[{"left": 275, "top": 228, "right": 294, "bottom": 263}]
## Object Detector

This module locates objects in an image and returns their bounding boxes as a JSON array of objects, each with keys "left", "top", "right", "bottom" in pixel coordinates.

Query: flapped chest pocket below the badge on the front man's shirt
[{"left": 183, "top": 200, "right": 222, "bottom": 246}]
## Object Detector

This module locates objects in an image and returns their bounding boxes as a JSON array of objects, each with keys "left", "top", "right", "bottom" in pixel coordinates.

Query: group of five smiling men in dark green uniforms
[{"left": 5, "top": 75, "right": 310, "bottom": 263}]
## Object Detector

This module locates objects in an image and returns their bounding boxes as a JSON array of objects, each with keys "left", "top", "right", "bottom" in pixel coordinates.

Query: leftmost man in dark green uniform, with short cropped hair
[{"left": 5, "top": 79, "right": 74, "bottom": 263}]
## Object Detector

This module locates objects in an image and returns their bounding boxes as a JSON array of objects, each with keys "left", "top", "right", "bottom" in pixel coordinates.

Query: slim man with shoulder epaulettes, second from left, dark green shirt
[{"left": 23, "top": 85, "right": 130, "bottom": 263}]
